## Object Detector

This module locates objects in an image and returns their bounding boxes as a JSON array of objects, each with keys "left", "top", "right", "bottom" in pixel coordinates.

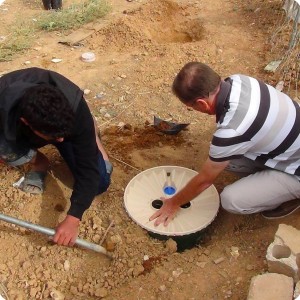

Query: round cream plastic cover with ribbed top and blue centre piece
[{"left": 124, "top": 166, "right": 219, "bottom": 236}]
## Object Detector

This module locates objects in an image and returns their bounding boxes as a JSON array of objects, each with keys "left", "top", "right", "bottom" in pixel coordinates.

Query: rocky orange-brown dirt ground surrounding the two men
[{"left": 0, "top": 0, "right": 300, "bottom": 300}]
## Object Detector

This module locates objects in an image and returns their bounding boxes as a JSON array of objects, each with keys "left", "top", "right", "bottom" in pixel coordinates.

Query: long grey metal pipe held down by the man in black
[{"left": 0, "top": 213, "right": 111, "bottom": 258}]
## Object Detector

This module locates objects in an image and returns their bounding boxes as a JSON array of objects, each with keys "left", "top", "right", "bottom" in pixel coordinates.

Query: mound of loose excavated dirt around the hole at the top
[{"left": 90, "top": 0, "right": 204, "bottom": 49}]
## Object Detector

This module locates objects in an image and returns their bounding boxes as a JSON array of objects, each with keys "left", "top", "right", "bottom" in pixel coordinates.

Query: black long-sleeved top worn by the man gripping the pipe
[{"left": 0, "top": 68, "right": 100, "bottom": 218}]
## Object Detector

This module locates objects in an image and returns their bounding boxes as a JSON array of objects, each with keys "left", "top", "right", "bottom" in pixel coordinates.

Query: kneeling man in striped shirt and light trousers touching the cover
[{"left": 150, "top": 62, "right": 300, "bottom": 226}]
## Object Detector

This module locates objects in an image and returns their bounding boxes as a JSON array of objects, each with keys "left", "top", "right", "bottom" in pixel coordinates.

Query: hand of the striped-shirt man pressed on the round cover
[{"left": 149, "top": 199, "right": 179, "bottom": 226}]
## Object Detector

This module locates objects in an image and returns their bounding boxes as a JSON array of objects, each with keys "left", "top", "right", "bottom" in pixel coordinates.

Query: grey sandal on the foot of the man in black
[{"left": 20, "top": 171, "right": 47, "bottom": 194}]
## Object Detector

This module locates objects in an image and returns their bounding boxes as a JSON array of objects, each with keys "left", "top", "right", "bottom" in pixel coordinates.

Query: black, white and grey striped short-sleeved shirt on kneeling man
[{"left": 209, "top": 75, "right": 300, "bottom": 179}]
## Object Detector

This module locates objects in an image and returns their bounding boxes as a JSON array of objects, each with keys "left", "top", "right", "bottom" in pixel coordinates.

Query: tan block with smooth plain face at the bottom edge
[{"left": 247, "top": 273, "right": 294, "bottom": 300}]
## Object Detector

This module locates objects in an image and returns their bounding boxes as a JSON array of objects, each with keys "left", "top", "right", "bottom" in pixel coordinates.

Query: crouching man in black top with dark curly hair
[{"left": 0, "top": 68, "right": 112, "bottom": 246}]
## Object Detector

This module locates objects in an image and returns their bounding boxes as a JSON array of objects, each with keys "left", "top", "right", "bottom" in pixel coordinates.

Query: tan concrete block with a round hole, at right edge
[{"left": 266, "top": 224, "right": 300, "bottom": 283}]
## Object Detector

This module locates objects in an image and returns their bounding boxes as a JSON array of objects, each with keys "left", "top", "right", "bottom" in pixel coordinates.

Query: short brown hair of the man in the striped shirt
[{"left": 172, "top": 62, "right": 221, "bottom": 103}]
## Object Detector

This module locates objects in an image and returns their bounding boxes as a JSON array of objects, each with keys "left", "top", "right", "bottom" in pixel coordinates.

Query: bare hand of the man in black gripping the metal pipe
[{"left": 53, "top": 215, "right": 80, "bottom": 246}]
